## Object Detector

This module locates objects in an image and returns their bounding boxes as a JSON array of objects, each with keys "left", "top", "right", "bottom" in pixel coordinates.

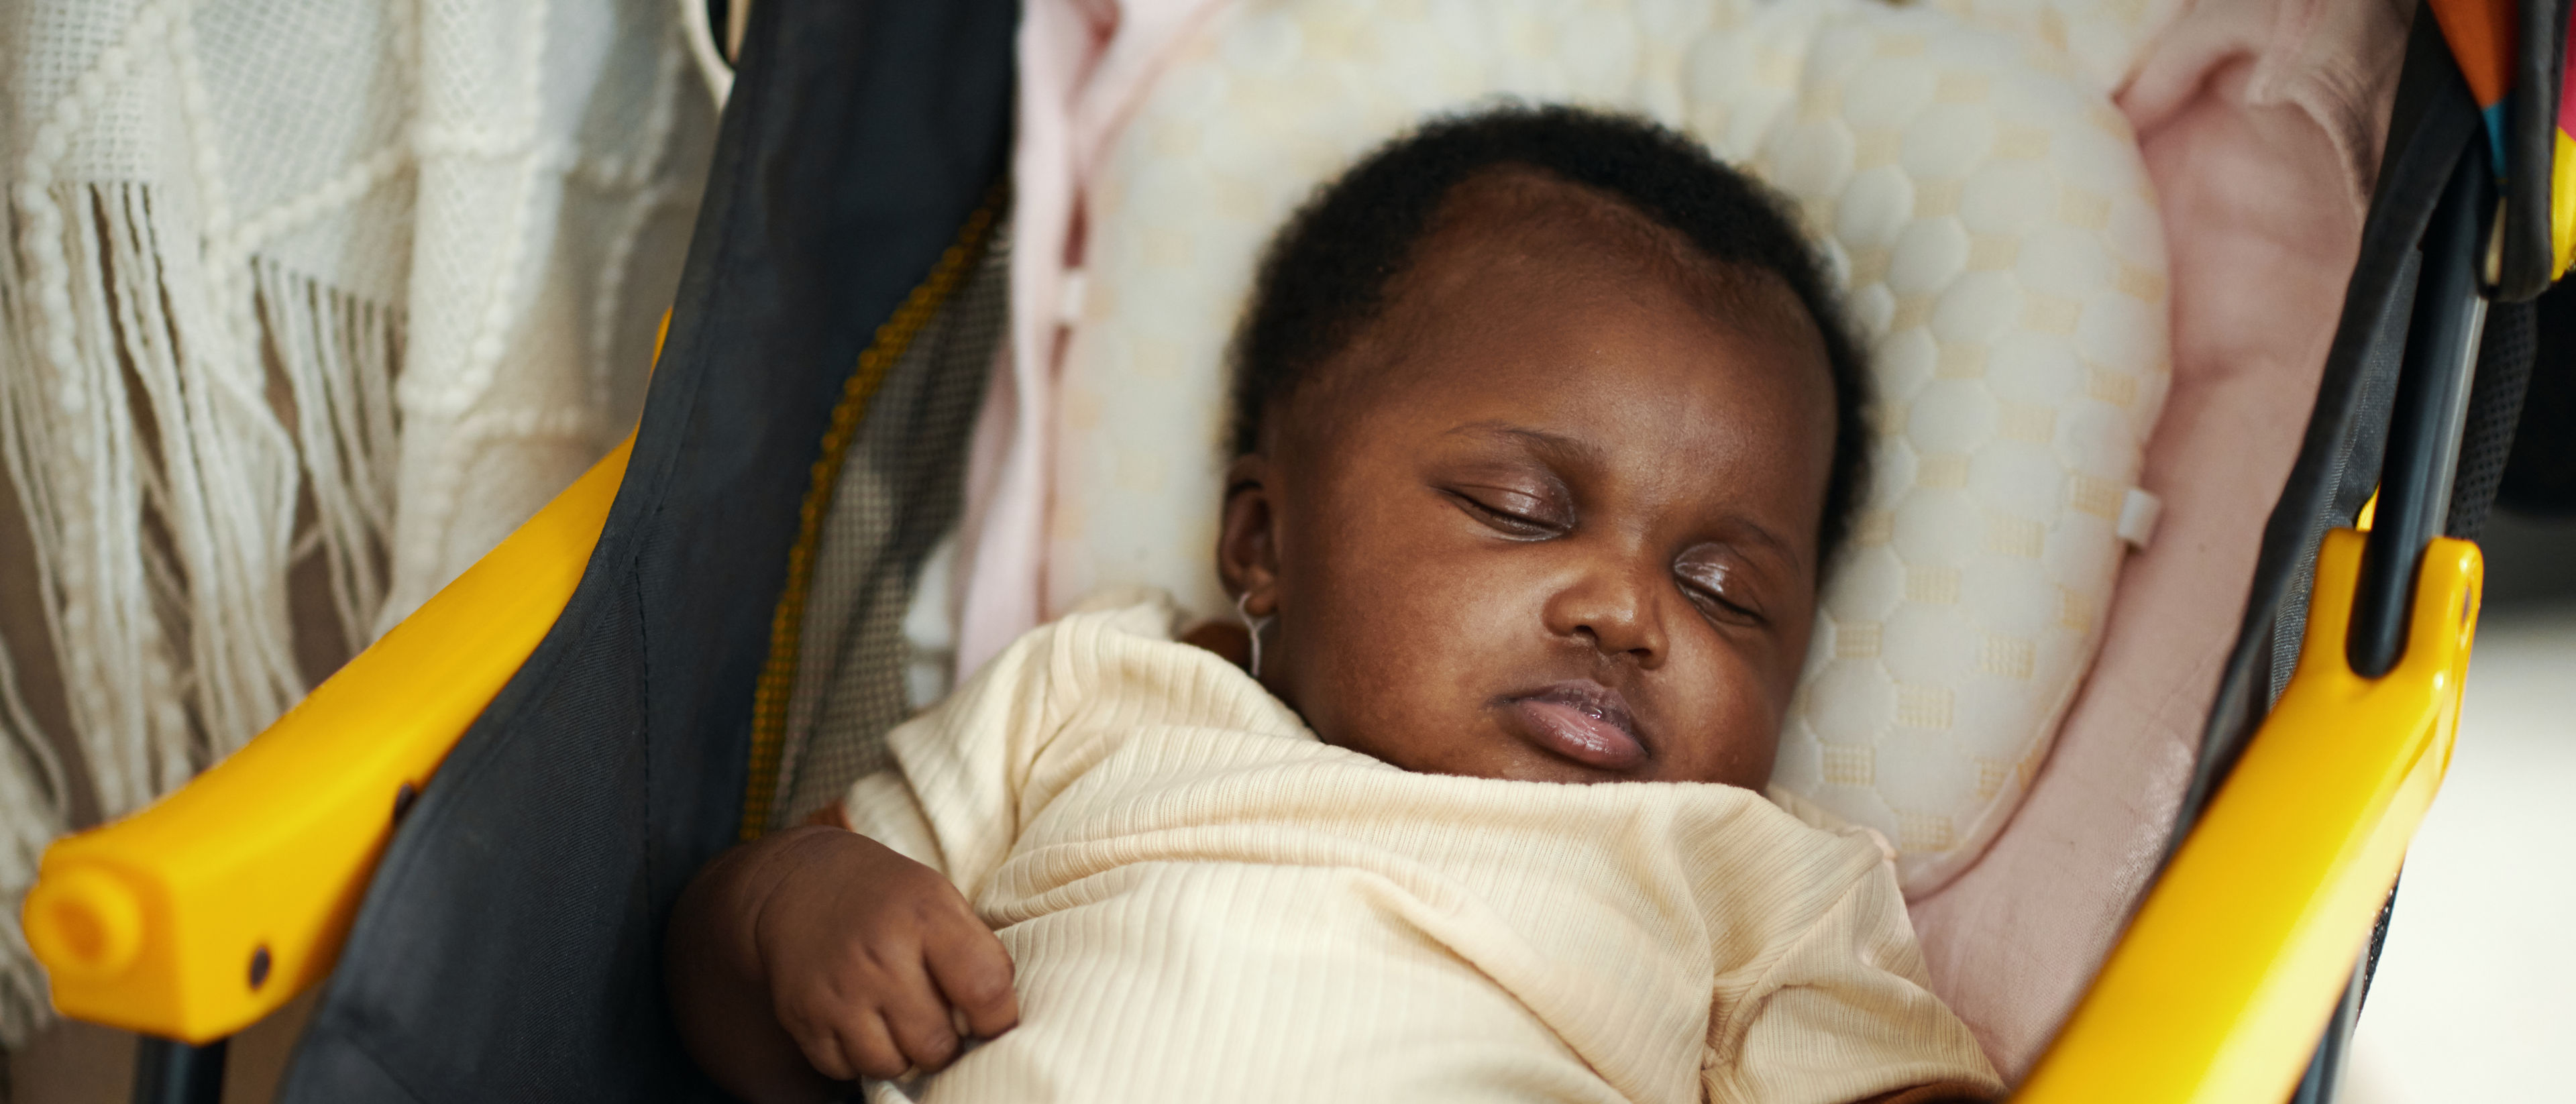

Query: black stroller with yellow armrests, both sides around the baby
[{"left": 25, "top": 0, "right": 2576, "bottom": 1104}]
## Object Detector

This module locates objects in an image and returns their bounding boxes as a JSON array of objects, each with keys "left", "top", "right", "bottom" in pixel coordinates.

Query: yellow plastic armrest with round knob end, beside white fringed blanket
[{"left": 25, "top": 437, "right": 634, "bottom": 1042}]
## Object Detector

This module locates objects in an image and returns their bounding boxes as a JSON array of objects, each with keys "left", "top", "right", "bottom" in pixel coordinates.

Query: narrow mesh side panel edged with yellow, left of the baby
[{"left": 770, "top": 237, "right": 1010, "bottom": 828}]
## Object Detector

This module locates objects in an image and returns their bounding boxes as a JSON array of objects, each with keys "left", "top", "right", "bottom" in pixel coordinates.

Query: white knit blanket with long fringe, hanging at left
[{"left": 0, "top": 0, "right": 714, "bottom": 1045}]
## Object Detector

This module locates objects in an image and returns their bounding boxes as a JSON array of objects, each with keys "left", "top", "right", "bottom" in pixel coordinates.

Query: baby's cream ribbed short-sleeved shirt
[{"left": 847, "top": 602, "right": 1999, "bottom": 1104}]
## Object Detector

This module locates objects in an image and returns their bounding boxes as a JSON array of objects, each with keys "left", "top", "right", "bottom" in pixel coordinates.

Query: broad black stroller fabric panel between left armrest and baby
[{"left": 281, "top": 0, "right": 1018, "bottom": 1104}]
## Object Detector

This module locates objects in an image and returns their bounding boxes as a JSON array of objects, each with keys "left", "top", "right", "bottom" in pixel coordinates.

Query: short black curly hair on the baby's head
[{"left": 1229, "top": 103, "right": 1870, "bottom": 566}]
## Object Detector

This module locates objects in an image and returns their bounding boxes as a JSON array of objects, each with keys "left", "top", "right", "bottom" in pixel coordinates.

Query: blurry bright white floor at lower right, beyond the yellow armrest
[{"left": 2344, "top": 605, "right": 2576, "bottom": 1104}]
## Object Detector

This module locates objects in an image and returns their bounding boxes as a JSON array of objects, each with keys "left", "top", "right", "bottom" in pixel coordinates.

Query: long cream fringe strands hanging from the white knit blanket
[{"left": 0, "top": 182, "right": 402, "bottom": 1045}]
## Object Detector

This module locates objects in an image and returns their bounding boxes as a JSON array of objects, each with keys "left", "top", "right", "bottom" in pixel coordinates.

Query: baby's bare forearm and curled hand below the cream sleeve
[{"left": 662, "top": 828, "right": 1020, "bottom": 1104}]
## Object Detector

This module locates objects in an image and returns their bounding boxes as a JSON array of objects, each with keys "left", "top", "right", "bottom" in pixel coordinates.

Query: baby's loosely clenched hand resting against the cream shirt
[{"left": 752, "top": 828, "right": 1020, "bottom": 1081}]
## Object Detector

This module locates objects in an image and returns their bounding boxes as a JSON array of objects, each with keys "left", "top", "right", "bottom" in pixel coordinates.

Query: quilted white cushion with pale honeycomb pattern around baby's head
[{"left": 1046, "top": 0, "right": 2166, "bottom": 893}]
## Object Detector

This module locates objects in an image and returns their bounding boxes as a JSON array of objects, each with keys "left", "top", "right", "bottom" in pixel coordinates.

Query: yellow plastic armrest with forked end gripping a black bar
[{"left": 2012, "top": 530, "right": 2483, "bottom": 1104}]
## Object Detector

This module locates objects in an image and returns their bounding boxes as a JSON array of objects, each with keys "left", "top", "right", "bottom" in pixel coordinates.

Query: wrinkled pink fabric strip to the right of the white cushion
[{"left": 1914, "top": 0, "right": 2406, "bottom": 1079}]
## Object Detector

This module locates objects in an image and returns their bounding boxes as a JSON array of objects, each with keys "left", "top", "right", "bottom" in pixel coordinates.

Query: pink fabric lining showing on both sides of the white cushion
[{"left": 958, "top": 0, "right": 2406, "bottom": 1079}]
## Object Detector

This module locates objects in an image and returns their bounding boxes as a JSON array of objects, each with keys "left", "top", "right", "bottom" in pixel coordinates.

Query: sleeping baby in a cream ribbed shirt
[{"left": 667, "top": 108, "right": 2002, "bottom": 1104}]
